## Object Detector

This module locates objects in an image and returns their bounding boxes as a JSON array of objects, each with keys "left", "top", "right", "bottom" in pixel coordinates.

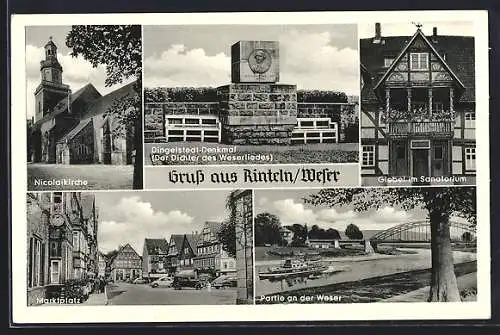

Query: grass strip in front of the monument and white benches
[{"left": 144, "top": 142, "right": 359, "bottom": 165}]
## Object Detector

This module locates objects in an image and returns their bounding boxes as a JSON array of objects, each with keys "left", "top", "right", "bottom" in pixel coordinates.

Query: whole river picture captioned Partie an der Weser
[{"left": 255, "top": 187, "right": 477, "bottom": 303}]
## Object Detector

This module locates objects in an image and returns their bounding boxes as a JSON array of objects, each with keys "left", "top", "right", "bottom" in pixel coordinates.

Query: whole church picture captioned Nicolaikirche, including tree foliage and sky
[{"left": 26, "top": 25, "right": 143, "bottom": 191}]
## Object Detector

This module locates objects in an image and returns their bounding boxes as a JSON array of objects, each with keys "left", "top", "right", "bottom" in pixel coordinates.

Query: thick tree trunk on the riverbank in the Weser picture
[{"left": 427, "top": 209, "right": 461, "bottom": 302}]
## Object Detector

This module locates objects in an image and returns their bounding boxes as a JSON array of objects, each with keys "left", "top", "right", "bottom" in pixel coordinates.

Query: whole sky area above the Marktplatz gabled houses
[{"left": 95, "top": 191, "right": 233, "bottom": 254}]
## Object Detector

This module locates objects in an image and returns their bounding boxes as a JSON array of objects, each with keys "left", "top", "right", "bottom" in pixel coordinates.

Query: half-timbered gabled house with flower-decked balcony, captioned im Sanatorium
[{"left": 360, "top": 23, "right": 476, "bottom": 186}]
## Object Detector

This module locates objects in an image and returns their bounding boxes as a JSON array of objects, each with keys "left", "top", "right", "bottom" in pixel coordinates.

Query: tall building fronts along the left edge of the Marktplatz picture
[{"left": 26, "top": 192, "right": 98, "bottom": 305}]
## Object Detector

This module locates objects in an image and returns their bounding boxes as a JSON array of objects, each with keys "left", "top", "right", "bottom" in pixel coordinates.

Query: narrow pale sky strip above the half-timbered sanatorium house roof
[{"left": 359, "top": 21, "right": 475, "bottom": 38}]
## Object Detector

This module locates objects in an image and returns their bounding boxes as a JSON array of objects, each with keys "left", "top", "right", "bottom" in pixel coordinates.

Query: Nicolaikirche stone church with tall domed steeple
[{"left": 28, "top": 38, "right": 137, "bottom": 165}]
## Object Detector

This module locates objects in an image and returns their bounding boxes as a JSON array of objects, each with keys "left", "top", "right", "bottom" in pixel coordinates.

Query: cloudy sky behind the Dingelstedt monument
[{"left": 143, "top": 24, "right": 359, "bottom": 95}]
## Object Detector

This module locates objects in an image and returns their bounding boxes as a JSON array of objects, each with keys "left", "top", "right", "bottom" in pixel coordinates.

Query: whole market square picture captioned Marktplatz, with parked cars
[{"left": 27, "top": 190, "right": 253, "bottom": 306}]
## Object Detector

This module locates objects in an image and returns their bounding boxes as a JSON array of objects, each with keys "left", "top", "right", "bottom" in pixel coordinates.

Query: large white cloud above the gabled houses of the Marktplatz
[{"left": 98, "top": 196, "right": 193, "bottom": 254}]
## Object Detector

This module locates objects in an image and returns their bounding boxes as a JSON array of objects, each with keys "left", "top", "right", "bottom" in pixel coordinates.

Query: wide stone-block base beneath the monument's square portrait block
[{"left": 217, "top": 83, "right": 297, "bottom": 144}]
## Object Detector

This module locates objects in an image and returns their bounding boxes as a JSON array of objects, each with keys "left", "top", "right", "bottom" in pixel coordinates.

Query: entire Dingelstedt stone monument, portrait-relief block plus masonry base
[{"left": 217, "top": 41, "right": 297, "bottom": 144}]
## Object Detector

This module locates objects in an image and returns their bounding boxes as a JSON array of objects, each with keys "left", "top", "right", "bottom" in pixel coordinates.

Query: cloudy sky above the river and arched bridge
[{"left": 254, "top": 190, "right": 464, "bottom": 232}]
